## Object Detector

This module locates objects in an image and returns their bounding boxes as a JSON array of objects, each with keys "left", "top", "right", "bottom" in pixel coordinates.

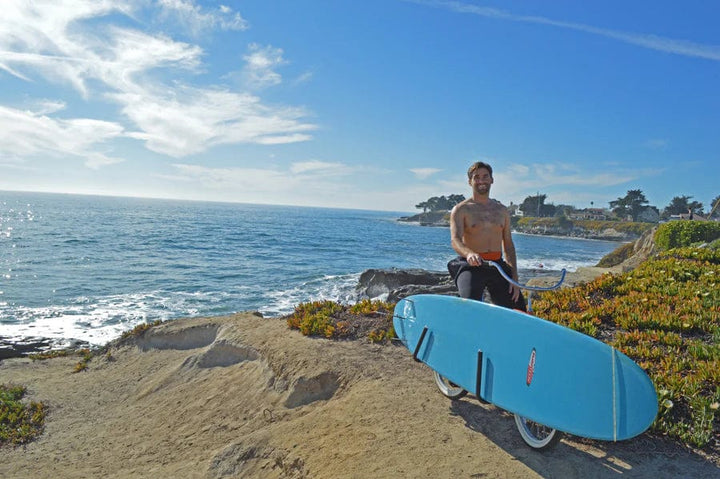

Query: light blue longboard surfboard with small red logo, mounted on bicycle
[{"left": 393, "top": 294, "right": 658, "bottom": 441}]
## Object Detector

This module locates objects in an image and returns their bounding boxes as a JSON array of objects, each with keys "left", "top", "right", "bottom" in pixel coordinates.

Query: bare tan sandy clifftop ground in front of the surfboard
[{"left": 0, "top": 314, "right": 720, "bottom": 479}]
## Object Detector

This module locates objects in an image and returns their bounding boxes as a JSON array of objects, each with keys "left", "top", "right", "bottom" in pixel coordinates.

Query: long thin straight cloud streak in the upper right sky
[{"left": 404, "top": 0, "right": 720, "bottom": 61}]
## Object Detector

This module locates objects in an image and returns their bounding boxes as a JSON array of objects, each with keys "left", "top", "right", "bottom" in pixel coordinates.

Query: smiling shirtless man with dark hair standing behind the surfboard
[{"left": 448, "top": 162, "right": 526, "bottom": 311}]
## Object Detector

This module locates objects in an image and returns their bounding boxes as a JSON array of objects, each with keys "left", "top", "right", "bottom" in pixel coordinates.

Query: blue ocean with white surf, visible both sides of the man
[{"left": 0, "top": 191, "right": 618, "bottom": 345}]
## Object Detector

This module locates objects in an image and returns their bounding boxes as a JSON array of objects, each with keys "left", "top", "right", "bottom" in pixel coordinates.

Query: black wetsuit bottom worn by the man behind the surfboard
[{"left": 448, "top": 256, "right": 527, "bottom": 311}]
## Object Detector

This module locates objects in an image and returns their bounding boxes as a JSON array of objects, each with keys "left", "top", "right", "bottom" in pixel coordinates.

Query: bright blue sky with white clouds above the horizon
[{"left": 0, "top": 0, "right": 720, "bottom": 212}]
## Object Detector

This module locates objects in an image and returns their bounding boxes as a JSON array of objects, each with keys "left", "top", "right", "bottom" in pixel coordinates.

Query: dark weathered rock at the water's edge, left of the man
[{"left": 356, "top": 268, "right": 457, "bottom": 302}]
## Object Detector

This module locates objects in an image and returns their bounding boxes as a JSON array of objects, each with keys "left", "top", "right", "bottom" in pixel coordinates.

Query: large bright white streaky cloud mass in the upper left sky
[{"left": 0, "top": 0, "right": 316, "bottom": 167}]
